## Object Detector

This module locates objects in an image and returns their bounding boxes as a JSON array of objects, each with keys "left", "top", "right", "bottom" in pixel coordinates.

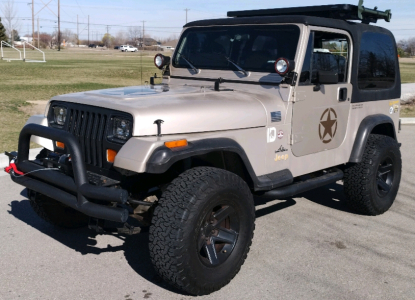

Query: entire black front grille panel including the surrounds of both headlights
[{"left": 48, "top": 101, "right": 133, "bottom": 169}]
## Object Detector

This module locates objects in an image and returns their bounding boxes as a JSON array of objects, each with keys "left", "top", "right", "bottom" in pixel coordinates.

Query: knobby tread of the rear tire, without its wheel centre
[{"left": 344, "top": 134, "right": 401, "bottom": 216}]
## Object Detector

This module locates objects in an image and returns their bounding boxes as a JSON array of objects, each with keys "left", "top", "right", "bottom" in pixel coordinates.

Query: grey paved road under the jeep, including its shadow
[{"left": 0, "top": 126, "right": 415, "bottom": 300}]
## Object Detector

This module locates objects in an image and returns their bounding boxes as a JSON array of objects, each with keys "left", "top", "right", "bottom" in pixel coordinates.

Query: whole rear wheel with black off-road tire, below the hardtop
[{"left": 344, "top": 134, "right": 402, "bottom": 216}]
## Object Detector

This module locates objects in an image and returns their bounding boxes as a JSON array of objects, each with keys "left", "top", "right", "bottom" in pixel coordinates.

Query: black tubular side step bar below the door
[{"left": 258, "top": 169, "right": 344, "bottom": 200}]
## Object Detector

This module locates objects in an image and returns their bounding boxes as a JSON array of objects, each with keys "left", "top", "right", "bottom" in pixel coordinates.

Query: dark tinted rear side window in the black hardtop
[{"left": 358, "top": 32, "right": 397, "bottom": 90}]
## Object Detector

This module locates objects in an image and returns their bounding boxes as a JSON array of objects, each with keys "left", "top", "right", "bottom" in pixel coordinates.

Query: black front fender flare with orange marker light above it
[{"left": 146, "top": 138, "right": 293, "bottom": 190}]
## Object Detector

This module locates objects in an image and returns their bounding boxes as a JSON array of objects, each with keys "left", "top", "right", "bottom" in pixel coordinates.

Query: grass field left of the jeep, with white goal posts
[{"left": 0, "top": 49, "right": 161, "bottom": 153}]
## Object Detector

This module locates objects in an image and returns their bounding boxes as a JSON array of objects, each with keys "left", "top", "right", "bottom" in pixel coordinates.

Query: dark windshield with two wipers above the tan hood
[{"left": 173, "top": 25, "right": 300, "bottom": 73}]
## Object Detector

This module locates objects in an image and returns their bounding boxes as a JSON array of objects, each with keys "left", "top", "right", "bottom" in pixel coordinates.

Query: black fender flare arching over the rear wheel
[{"left": 349, "top": 114, "right": 396, "bottom": 163}]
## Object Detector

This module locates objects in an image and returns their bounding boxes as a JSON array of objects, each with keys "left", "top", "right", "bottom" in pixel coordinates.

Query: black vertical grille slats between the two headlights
[{"left": 65, "top": 108, "right": 109, "bottom": 168}]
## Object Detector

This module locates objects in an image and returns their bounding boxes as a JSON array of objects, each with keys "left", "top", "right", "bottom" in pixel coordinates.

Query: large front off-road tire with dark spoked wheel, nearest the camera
[{"left": 149, "top": 167, "right": 255, "bottom": 295}]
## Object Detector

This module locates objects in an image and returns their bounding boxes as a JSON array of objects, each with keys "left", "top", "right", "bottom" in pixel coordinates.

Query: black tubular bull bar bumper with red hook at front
[{"left": 10, "top": 124, "right": 129, "bottom": 223}]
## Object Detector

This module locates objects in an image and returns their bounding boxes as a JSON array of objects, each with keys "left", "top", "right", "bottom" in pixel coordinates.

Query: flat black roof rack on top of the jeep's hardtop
[{"left": 228, "top": 0, "right": 392, "bottom": 24}]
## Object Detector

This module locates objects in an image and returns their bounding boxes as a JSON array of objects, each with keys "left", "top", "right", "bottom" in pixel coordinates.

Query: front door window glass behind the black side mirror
[{"left": 300, "top": 31, "right": 349, "bottom": 84}]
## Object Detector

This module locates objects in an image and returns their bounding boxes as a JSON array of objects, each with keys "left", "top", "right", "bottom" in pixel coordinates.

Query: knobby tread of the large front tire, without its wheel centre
[{"left": 149, "top": 167, "right": 255, "bottom": 295}]
